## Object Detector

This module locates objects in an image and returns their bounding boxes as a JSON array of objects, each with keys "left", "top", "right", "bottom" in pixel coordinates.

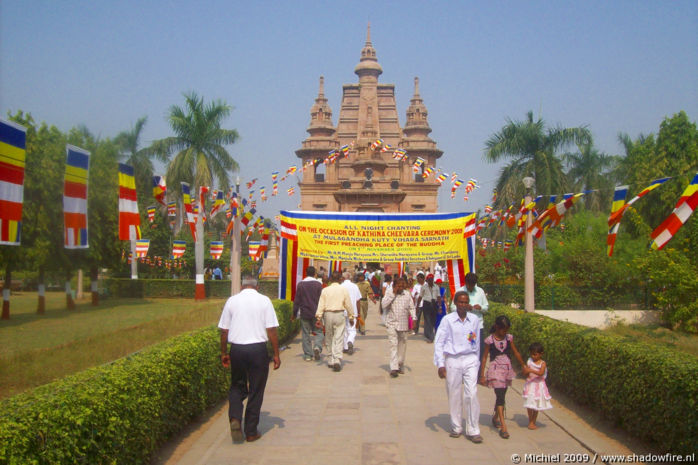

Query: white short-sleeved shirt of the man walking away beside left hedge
[{"left": 218, "top": 289, "right": 279, "bottom": 344}]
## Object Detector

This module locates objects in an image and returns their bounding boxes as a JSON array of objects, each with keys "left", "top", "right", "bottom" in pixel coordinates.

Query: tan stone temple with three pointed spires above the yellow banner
[{"left": 296, "top": 25, "right": 443, "bottom": 212}]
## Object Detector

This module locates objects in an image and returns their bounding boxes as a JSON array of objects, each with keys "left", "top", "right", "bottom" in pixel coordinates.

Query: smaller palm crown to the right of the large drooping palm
[{"left": 562, "top": 143, "right": 616, "bottom": 211}]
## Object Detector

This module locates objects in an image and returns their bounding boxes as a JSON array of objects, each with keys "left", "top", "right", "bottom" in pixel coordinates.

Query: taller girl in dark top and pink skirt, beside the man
[{"left": 480, "top": 315, "right": 524, "bottom": 439}]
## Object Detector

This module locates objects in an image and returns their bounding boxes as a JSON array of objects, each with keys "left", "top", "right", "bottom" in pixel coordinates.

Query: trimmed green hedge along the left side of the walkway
[{"left": 0, "top": 300, "right": 299, "bottom": 465}]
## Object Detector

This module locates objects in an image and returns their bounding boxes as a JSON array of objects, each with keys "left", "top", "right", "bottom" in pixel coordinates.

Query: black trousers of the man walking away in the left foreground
[{"left": 228, "top": 342, "right": 269, "bottom": 436}]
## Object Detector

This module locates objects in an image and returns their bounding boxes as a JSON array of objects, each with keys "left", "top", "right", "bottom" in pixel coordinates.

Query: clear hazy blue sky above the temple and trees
[{"left": 0, "top": 0, "right": 698, "bottom": 217}]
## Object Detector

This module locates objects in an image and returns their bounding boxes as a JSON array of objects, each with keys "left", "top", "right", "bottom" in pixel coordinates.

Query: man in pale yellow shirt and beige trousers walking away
[{"left": 315, "top": 271, "right": 356, "bottom": 371}]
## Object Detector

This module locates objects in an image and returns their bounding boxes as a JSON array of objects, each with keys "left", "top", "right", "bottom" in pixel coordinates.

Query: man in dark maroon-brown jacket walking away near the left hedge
[{"left": 291, "top": 266, "right": 325, "bottom": 362}]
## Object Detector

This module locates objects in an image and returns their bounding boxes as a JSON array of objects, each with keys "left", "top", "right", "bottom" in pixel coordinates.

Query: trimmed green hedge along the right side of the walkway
[{"left": 485, "top": 304, "right": 698, "bottom": 454}]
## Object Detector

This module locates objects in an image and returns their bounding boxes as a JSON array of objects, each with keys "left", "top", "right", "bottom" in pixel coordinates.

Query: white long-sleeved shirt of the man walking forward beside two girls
[{"left": 434, "top": 312, "right": 480, "bottom": 368}]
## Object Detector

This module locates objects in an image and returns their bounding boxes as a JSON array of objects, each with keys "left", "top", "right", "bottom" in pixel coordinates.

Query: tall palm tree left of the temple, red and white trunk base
[{"left": 152, "top": 92, "right": 239, "bottom": 299}]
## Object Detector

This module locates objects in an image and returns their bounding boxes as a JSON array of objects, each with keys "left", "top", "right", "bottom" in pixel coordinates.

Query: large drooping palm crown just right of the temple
[{"left": 484, "top": 111, "right": 591, "bottom": 205}]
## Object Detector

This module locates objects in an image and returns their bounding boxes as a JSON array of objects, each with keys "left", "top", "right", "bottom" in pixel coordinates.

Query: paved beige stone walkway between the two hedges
[{"left": 160, "top": 302, "right": 632, "bottom": 465}]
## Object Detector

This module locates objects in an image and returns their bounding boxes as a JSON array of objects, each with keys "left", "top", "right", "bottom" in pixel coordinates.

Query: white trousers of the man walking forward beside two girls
[{"left": 445, "top": 354, "right": 480, "bottom": 436}]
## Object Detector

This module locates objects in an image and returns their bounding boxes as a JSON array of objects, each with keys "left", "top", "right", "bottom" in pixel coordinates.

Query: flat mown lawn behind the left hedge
[{"left": 0, "top": 292, "right": 225, "bottom": 398}]
